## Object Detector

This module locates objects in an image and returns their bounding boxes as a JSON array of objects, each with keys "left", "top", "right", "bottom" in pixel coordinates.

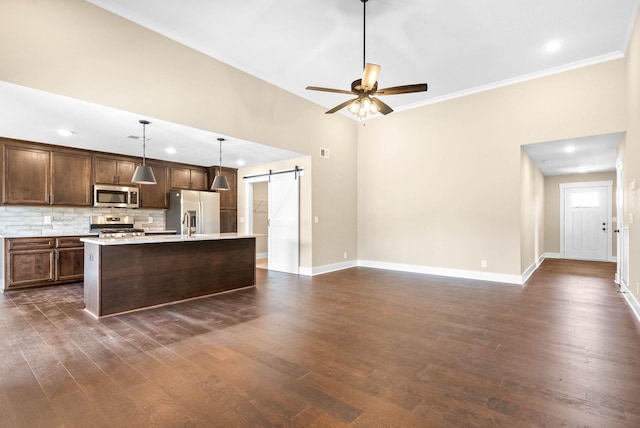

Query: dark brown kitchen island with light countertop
[{"left": 82, "top": 233, "right": 256, "bottom": 318}]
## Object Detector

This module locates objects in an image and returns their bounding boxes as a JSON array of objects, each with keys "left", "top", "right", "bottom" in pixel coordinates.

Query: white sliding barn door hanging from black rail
[{"left": 268, "top": 171, "right": 300, "bottom": 273}]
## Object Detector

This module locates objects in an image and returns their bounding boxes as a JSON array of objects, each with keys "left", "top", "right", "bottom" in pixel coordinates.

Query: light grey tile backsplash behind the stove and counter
[{"left": 0, "top": 206, "right": 165, "bottom": 237}]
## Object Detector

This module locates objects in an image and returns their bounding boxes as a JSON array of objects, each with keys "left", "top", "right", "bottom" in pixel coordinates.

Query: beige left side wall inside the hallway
[{"left": 520, "top": 149, "right": 546, "bottom": 272}]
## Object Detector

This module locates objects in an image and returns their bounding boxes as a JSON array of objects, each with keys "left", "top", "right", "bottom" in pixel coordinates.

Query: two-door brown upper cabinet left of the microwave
[{"left": 2, "top": 143, "right": 91, "bottom": 206}]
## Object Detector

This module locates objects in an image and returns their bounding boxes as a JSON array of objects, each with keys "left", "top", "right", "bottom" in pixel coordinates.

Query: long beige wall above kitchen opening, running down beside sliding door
[{"left": 0, "top": 0, "right": 357, "bottom": 266}]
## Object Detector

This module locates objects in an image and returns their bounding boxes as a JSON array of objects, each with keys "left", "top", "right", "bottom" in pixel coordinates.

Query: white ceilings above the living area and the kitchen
[{"left": 0, "top": 0, "right": 640, "bottom": 172}]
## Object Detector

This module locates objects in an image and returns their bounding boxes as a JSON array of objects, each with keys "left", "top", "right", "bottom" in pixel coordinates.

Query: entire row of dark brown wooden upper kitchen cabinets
[{"left": 0, "top": 137, "right": 237, "bottom": 209}]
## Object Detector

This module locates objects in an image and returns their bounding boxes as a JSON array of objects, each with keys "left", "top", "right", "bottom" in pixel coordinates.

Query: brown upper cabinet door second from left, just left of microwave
[{"left": 51, "top": 151, "right": 91, "bottom": 207}]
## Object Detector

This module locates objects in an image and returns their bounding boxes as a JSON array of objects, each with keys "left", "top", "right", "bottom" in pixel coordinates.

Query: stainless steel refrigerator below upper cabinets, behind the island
[{"left": 166, "top": 189, "right": 220, "bottom": 235}]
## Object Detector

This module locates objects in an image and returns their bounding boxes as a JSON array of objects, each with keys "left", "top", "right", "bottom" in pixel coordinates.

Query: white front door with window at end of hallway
[{"left": 561, "top": 183, "right": 611, "bottom": 261}]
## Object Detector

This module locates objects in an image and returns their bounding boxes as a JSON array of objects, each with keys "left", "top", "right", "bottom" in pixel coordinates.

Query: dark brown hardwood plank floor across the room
[{"left": 0, "top": 260, "right": 640, "bottom": 427}]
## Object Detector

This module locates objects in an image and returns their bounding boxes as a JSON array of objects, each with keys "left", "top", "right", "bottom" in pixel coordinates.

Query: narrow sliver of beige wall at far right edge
[{"left": 621, "top": 13, "right": 640, "bottom": 300}]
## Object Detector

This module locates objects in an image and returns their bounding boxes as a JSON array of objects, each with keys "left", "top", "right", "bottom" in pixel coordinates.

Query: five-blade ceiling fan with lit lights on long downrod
[{"left": 306, "top": 0, "right": 427, "bottom": 118}]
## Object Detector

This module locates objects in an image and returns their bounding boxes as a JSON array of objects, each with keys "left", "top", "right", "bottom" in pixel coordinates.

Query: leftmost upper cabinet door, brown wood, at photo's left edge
[{"left": 2, "top": 145, "right": 49, "bottom": 205}]
